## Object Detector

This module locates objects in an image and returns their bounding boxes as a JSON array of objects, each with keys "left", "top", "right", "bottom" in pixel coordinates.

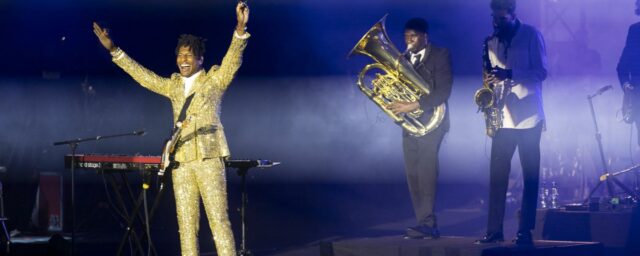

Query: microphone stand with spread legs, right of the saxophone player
[{"left": 583, "top": 89, "right": 638, "bottom": 204}]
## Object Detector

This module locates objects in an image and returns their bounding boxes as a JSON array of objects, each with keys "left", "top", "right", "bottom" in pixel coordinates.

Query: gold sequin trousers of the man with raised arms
[{"left": 172, "top": 158, "right": 236, "bottom": 256}]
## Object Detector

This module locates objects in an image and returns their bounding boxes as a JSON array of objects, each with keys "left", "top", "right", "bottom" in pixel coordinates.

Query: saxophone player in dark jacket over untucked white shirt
[{"left": 476, "top": 0, "right": 547, "bottom": 245}]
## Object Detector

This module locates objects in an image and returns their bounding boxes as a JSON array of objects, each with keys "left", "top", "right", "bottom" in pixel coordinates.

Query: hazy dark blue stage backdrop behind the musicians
[{"left": 0, "top": 0, "right": 638, "bottom": 255}]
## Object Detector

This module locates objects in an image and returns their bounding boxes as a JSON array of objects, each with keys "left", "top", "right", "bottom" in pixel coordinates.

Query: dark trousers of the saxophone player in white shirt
[{"left": 487, "top": 123, "right": 542, "bottom": 232}]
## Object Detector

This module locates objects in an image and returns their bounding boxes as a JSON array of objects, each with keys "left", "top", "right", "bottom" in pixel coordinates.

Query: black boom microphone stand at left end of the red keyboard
[{"left": 53, "top": 130, "right": 146, "bottom": 255}]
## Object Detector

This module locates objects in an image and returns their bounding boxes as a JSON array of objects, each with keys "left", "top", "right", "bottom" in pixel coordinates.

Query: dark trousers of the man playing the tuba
[{"left": 402, "top": 124, "right": 448, "bottom": 228}]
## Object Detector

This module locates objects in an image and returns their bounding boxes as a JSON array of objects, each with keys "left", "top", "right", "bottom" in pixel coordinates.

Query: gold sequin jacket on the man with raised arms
[{"left": 113, "top": 35, "right": 248, "bottom": 162}]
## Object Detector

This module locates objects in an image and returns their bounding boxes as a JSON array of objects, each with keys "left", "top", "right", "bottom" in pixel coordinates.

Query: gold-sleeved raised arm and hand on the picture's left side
[{"left": 93, "top": 22, "right": 170, "bottom": 97}]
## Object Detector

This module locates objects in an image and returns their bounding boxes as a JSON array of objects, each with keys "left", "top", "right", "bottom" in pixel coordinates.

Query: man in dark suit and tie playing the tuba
[{"left": 388, "top": 18, "right": 453, "bottom": 239}]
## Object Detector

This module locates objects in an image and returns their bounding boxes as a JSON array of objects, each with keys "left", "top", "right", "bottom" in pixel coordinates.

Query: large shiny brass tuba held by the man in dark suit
[{"left": 349, "top": 15, "right": 446, "bottom": 137}]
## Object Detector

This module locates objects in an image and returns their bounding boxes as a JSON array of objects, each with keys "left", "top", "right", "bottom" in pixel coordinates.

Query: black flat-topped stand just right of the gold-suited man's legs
[{"left": 225, "top": 160, "right": 280, "bottom": 256}]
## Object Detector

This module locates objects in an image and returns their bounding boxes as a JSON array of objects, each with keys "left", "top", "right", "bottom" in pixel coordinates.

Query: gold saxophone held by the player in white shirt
[{"left": 474, "top": 36, "right": 510, "bottom": 137}]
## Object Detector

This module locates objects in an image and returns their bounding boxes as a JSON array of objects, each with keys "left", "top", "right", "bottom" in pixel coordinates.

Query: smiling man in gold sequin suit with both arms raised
[{"left": 93, "top": 2, "right": 250, "bottom": 256}]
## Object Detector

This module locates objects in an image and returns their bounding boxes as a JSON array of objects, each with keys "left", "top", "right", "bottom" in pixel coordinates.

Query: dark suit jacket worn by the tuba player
[{"left": 404, "top": 45, "right": 453, "bottom": 136}]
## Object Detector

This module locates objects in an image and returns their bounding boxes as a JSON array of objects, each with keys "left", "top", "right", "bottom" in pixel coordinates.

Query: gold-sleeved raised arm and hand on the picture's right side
[{"left": 208, "top": 2, "right": 250, "bottom": 89}]
